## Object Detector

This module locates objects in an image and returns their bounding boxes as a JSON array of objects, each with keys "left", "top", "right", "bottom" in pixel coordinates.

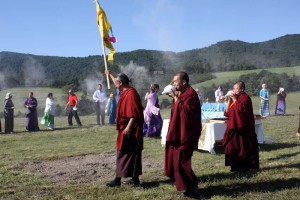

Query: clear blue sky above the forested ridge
[{"left": 0, "top": 0, "right": 300, "bottom": 57}]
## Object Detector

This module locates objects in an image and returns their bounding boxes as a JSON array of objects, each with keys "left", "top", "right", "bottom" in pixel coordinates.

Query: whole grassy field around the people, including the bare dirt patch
[{"left": 0, "top": 68, "right": 300, "bottom": 200}]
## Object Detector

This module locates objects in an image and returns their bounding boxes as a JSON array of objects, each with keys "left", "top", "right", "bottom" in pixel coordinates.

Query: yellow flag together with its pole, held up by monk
[{"left": 95, "top": 0, "right": 116, "bottom": 89}]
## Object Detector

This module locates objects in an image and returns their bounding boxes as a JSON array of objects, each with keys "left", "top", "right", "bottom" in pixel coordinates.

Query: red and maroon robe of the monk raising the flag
[{"left": 116, "top": 87, "right": 144, "bottom": 178}]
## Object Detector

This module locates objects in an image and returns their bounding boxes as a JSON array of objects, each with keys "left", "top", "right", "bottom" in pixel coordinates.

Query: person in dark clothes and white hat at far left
[{"left": 0, "top": 92, "right": 15, "bottom": 133}]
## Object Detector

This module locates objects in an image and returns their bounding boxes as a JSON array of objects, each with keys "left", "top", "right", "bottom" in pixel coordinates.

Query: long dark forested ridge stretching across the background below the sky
[{"left": 0, "top": 34, "right": 300, "bottom": 87}]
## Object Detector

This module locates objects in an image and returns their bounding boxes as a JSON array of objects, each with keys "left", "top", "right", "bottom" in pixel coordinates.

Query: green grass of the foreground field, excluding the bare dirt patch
[{"left": 0, "top": 93, "right": 300, "bottom": 200}]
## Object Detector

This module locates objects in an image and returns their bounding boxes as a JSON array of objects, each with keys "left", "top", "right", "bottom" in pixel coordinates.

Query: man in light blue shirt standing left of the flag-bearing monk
[{"left": 93, "top": 84, "right": 107, "bottom": 125}]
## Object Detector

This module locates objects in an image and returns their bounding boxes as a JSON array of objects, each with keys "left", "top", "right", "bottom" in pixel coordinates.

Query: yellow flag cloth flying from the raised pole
[{"left": 96, "top": 0, "right": 116, "bottom": 63}]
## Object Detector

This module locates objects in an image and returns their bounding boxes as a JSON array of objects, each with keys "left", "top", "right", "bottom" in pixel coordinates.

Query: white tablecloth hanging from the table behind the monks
[{"left": 161, "top": 119, "right": 264, "bottom": 154}]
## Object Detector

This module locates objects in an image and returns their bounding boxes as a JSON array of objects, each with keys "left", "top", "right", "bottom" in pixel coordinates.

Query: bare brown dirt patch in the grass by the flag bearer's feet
[{"left": 22, "top": 153, "right": 163, "bottom": 185}]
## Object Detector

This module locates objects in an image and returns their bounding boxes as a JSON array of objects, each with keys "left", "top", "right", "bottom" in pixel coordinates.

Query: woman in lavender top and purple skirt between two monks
[{"left": 143, "top": 84, "right": 163, "bottom": 137}]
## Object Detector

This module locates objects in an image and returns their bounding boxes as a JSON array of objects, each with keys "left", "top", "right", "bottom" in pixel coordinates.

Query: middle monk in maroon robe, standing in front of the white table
[{"left": 164, "top": 72, "right": 202, "bottom": 195}]
